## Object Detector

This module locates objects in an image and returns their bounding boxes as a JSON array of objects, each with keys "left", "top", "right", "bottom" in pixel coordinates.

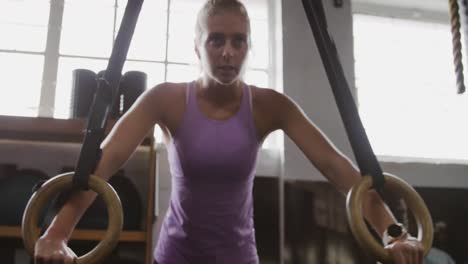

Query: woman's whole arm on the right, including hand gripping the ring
[{"left": 270, "top": 89, "right": 424, "bottom": 264}]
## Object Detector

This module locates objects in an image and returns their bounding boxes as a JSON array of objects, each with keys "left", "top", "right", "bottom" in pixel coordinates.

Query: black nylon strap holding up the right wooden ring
[{"left": 302, "top": 0, "right": 384, "bottom": 196}]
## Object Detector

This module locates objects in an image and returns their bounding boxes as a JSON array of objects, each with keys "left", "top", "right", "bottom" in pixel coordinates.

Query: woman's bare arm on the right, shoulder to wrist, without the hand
[{"left": 276, "top": 90, "right": 396, "bottom": 235}]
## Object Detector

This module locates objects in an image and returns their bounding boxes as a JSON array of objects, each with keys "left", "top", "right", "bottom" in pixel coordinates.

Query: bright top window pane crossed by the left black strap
[{"left": 116, "top": 0, "right": 167, "bottom": 61}]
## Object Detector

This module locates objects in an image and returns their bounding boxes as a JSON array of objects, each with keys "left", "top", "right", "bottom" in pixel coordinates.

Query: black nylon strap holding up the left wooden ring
[{"left": 73, "top": 0, "right": 143, "bottom": 189}]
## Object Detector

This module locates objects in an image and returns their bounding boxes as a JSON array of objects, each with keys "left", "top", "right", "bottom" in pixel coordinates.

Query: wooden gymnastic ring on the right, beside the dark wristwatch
[{"left": 346, "top": 173, "right": 433, "bottom": 263}]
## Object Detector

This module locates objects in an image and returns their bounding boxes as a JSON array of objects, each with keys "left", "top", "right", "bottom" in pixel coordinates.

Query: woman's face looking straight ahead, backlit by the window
[{"left": 196, "top": 11, "right": 249, "bottom": 85}]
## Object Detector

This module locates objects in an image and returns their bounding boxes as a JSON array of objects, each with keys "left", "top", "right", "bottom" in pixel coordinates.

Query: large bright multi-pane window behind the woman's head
[{"left": 0, "top": 0, "right": 279, "bottom": 146}]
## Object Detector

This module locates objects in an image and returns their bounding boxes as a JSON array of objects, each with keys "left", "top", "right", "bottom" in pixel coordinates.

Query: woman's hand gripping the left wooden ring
[{"left": 34, "top": 236, "right": 77, "bottom": 264}]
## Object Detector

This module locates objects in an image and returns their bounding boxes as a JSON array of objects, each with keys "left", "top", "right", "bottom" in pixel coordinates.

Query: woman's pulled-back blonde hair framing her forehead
[{"left": 195, "top": 0, "right": 251, "bottom": 47}]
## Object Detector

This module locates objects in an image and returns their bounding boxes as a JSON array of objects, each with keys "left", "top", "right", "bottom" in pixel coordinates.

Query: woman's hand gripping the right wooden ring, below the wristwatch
[{"left": 385, "top": 236, "right": 424, "bottom": 264}]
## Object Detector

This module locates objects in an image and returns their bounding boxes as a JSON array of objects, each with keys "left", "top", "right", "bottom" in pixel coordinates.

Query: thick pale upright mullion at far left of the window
[{"left": 38, "top": 0, "right": 64, "bottom": 117}]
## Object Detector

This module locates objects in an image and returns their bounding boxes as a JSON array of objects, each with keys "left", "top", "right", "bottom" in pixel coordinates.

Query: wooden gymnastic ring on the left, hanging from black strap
[{"left": 21, "top": 172, "right": 123, "bottom": 264}]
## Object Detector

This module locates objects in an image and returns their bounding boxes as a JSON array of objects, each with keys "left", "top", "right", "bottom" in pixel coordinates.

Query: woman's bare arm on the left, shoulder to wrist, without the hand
[{"left": 43, "top": 84, "right": 165, "bottom": 241}]
